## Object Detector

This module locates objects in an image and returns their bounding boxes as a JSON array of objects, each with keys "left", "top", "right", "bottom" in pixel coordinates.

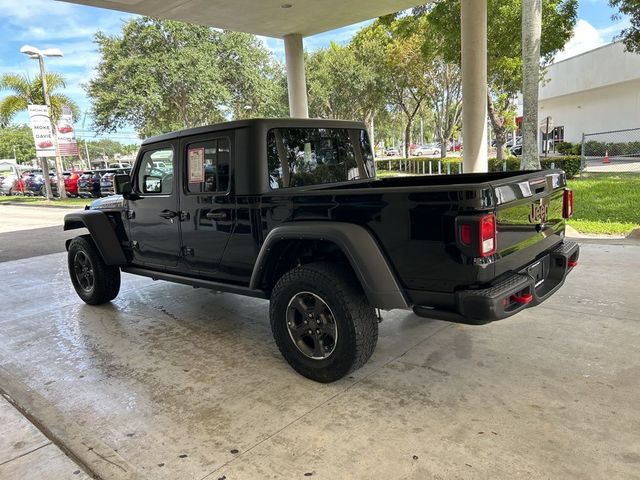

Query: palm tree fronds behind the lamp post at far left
[{"left": 0, "top": 72, "right": 79, "bottom": 127}]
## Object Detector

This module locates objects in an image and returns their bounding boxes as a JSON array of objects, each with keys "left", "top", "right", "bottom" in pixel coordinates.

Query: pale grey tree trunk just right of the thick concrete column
[{"left": 520, "top": 0, "right": 542, "bottom": 170}]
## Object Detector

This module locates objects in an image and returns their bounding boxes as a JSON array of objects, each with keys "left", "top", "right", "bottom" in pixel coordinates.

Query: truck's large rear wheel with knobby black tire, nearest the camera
[{"left": 269, "top": 263, "right": 378, "bottom": 383}]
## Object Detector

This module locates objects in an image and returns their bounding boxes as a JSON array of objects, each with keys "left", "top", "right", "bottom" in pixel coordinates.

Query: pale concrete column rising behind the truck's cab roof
[{"left": 284, "top": 33, "right": 309, "bottom": 118}]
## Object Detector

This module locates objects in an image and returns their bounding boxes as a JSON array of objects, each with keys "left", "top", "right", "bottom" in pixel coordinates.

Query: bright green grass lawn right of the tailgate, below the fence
[{"left": 569, "top": 173, "right": 640, "bottom": 235}]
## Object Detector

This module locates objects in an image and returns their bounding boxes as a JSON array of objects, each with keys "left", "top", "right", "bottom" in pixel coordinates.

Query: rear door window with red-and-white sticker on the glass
[{"left": 186, "top": 137, "right": 231, "bottom": 193}]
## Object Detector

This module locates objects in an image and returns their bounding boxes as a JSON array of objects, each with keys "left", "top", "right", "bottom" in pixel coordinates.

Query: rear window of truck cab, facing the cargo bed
[{"left": 267, "top": 128, "right": 374, "bottom": 189}]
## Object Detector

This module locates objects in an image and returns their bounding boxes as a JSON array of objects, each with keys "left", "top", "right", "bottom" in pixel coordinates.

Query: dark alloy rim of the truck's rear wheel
[{"left": 287, "top": 292, "right": 338, "bottom": 360}]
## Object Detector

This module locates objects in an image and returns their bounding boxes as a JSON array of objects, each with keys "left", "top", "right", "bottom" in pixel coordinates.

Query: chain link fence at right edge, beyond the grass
[{"left": 582, "top": 128, "right": 640, "bottom": 174}]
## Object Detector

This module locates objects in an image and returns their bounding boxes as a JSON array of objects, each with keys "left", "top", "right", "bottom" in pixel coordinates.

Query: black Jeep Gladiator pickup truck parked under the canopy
[{"left": 64, "top": 119, "right": 579, "bottom": 382}]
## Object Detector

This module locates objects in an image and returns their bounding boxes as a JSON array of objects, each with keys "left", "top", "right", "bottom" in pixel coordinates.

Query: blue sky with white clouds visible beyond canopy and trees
[{"left": 0, "top": 0, "right": 628, "bottom": 142}]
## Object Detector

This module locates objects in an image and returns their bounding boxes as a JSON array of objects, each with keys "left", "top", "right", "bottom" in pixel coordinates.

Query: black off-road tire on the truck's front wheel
[{"left": 67, "top": 235, "right": 120, "bottom": 305}]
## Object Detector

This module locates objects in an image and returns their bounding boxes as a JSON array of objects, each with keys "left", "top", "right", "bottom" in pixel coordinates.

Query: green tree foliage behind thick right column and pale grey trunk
[{"left": 427, "top": 0, "right": 577, "bottom": 163}]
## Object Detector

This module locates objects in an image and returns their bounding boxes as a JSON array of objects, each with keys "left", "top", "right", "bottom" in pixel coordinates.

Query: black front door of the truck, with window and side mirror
[{"left": 127, "top": 143, "right": 180, "bottom": 270}]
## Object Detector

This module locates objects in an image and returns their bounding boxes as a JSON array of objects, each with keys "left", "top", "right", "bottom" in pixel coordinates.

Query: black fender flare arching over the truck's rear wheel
[{"left": 249, "top": 221, "right": 409, "bottom": 310}]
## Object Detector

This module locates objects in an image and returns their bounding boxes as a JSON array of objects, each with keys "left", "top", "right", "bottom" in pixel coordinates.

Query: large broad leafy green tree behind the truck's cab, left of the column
[{"left": 87, "top": 17, "right": 282, "bottom": 136}]
